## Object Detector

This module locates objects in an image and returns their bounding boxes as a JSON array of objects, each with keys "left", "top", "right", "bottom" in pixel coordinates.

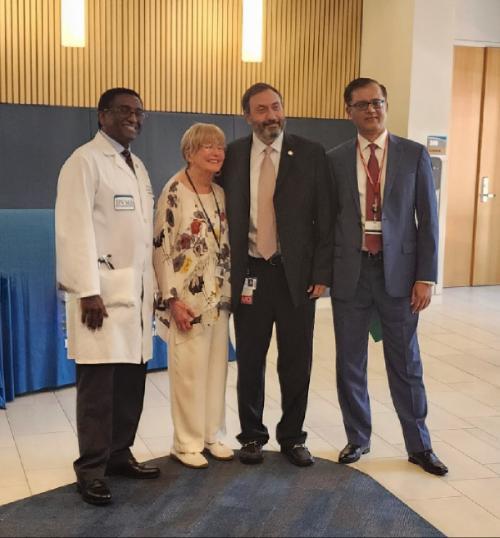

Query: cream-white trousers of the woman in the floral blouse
[{"left": 168, "top": 311, "right": 229, "bottom": 452}]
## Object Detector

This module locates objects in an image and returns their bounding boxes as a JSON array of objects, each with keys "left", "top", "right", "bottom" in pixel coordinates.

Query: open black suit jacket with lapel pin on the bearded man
[{"left": 218, "top": 133, "right": 332, "bottom": 311}]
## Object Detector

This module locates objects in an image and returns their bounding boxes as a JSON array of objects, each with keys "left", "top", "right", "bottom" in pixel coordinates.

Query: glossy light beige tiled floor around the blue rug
[{"left": 0, "top": 287, "right": 500, "bottom": 536}]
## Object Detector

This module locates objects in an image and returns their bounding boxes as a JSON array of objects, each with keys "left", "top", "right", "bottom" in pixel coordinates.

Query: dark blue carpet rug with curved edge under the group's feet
[{"left": 0, "top": 452, "right": 443, "bottom": 537}]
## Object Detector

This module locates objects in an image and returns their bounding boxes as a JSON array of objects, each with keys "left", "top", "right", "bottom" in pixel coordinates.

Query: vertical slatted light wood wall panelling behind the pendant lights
[{"left": 0, "top": 0, "right": 362, "bottom": 118}]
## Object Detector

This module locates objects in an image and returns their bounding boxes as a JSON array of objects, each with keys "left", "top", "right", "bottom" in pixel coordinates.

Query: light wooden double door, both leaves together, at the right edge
[{"left": 443, "top": 47, "right": 500, "bottom": 287}]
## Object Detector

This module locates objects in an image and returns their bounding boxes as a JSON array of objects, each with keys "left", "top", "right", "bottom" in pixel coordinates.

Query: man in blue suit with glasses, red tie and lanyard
[{"left": 328, "top": 78, "right": 448, "bottom": 475}]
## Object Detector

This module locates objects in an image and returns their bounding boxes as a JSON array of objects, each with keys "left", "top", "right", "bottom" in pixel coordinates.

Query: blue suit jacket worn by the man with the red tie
[{"left": 328, "top": 130, "right": 439, "bottom": 299}]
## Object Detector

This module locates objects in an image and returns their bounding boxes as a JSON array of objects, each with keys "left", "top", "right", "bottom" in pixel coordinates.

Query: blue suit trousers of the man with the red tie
[{"left": 333, "top": 257, "right": 431, "bottom": 452}]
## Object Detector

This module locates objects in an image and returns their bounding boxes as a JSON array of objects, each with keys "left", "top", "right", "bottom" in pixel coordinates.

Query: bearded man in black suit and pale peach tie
[{"left": 220, "top": 83, "right": 332, "bottom": 466}]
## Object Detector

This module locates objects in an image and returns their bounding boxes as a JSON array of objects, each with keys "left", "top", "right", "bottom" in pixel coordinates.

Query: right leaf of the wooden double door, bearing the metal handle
[{"left": 472, "top": 48, "right": 500, "bottom": 286}]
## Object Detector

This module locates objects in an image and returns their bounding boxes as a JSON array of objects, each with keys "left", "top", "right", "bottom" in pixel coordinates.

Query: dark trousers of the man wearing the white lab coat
[{"left": 74, "top": 363, "right": 146, "bottom": 480}]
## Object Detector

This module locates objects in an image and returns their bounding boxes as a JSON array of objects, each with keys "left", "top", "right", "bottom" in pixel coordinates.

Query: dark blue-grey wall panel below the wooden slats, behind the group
[{"left": 0, "top": 104, "right": 354, "bottom": 209}]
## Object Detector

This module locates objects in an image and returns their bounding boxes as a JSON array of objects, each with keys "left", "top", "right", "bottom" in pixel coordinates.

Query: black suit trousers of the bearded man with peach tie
[{"left": 234, "top": 258, "right": 315, "bottom": 447}]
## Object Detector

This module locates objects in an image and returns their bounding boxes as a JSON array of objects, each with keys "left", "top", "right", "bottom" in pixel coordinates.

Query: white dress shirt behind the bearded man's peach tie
[{"left": 248, "top": 133, "right": 283, "bottom": 258}]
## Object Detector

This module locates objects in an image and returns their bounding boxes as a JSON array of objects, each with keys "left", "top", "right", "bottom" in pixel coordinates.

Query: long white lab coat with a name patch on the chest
[{"left": 55, "top": 132, "right": 155, "bottom": 364}]
